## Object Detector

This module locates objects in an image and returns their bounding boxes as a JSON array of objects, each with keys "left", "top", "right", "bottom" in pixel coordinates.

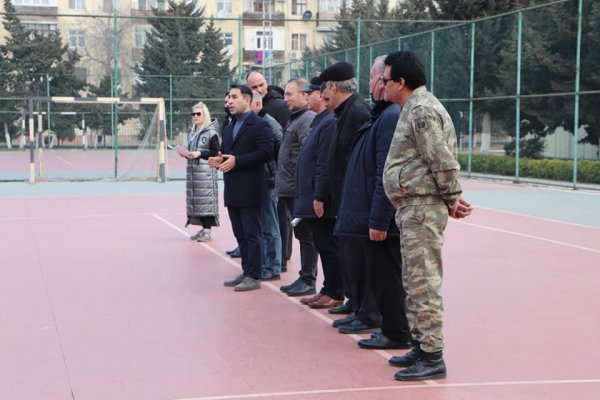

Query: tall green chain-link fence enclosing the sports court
[{"left": 0, "top": 0, "right": 600, "bottom": 186}]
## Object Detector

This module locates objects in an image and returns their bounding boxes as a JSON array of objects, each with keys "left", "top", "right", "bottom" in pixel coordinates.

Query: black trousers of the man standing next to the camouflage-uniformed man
[{"left": 363, "top": 237, "right": 411, "bottom": 341}]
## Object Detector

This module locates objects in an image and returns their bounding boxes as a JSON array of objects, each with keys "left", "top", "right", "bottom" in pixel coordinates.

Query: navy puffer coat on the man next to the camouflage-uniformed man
[{"left": 334, "top": 102, "right": 400, "bottom": 237}]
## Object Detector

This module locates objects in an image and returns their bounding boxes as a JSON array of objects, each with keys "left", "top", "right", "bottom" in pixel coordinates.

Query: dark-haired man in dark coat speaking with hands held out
[{"left": 208, "top": 85, "right": 273, "bottom": 292}]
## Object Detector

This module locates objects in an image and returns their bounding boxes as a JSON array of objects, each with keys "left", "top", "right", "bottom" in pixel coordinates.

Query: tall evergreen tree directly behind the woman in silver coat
[{"left": 134, "top": 0, "right": 205, "bottom": 134}]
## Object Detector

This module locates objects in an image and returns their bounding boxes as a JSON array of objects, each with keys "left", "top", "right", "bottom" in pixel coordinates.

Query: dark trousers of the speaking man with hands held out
[{"left": 227, "top": 207, "right": 262, "bottom": 279}]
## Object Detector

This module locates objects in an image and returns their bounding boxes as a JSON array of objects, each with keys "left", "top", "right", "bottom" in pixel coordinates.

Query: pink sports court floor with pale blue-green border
[{"left": 0, "top": 179, "right": 600, "bottom": 400}]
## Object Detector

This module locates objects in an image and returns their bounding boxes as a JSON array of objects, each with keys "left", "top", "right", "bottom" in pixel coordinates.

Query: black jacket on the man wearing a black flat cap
[{"left": 327, "top": 93, "right": 371, "bottom": 213}]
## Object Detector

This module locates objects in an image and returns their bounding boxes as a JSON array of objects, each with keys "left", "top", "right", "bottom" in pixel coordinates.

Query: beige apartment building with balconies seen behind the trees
[{"left": 0, "top": 0, "right": 343, "bottom": 89}]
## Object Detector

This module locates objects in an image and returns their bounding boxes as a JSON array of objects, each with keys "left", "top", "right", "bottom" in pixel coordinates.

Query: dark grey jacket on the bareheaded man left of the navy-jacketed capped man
[{"left": 275, "top": 108, "right": 316, "bottom": 197}]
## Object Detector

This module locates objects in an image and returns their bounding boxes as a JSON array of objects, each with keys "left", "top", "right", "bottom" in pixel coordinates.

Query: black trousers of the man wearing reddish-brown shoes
[{"left": 310, "top": 218, "right": 344, "bottom": 300}]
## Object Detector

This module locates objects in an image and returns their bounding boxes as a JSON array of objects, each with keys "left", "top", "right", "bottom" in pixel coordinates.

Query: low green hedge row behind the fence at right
[{"left": 458, "top": 154, "right": 600, "bottom": 184}]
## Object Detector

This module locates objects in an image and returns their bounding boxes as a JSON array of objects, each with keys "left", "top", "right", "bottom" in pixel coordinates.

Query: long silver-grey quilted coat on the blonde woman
[{"left": 186, "top": 119, "right": 219, "bottom": 226}]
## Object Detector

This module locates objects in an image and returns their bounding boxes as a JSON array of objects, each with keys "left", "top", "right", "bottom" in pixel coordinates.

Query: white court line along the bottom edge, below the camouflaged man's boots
[{"left": 173, "top": 379, "right": 600, "bottom": 400}]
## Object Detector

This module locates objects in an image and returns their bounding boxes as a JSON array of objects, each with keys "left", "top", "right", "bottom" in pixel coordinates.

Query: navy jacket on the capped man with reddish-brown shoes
[{"left": 293, "top": 110, "right": 335, "bottom": 218}]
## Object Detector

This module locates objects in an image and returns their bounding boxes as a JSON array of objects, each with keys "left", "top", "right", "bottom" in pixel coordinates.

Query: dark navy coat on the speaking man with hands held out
[{"left": 221, "top": 112, "right": 273, "bottom": 208}]
